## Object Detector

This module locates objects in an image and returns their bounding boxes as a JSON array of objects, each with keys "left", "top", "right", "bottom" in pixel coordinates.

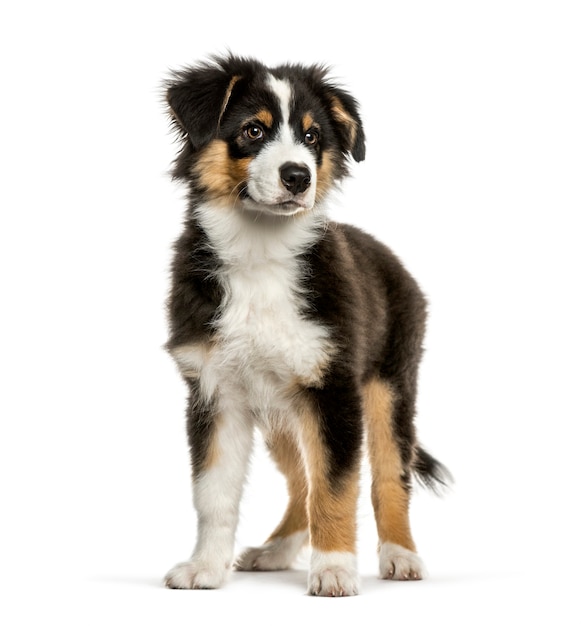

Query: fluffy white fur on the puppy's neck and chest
[{"left": 174, "top": 207, "right": 331, "bottom": 414}]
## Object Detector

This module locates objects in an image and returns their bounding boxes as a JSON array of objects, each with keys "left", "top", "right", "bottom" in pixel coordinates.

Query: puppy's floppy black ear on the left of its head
[{"left": 166, "top": 64, "right": 241, "bottom": 152}]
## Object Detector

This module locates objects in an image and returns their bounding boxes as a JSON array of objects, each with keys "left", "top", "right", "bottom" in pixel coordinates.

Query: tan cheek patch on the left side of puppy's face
[{"left": 192, "top": 139, "right": 252, "bottom": 205}]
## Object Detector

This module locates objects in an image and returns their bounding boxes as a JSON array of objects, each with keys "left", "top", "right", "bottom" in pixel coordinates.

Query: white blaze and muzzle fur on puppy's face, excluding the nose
[{"left": 246, "top": 76, "right": 317, "bottom": 215}]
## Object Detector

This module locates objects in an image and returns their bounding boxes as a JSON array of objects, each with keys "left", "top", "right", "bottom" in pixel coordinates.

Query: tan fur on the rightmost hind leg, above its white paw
[{"left": 364, "top": 379, "right": 415, "bottom": 552}]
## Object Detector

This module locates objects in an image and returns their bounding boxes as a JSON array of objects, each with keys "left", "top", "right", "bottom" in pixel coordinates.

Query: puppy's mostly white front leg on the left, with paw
[{"left": 165, "top": 380, "right": 252, "bottom": 589}]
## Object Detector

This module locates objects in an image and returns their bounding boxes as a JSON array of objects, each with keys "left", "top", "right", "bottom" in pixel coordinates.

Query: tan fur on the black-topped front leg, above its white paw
[{"left": 300, "top": 394, "right": 359, "bottom": 553}]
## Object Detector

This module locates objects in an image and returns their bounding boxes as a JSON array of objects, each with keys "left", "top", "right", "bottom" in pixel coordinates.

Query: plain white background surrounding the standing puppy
[{"left": 0, "top": 0, "right": 581, "bottom": 625}]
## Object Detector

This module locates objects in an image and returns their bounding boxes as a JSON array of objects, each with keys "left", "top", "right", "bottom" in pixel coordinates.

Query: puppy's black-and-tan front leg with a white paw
[{"left": 301, "top": 384, "right": 363, "bottom": 596}]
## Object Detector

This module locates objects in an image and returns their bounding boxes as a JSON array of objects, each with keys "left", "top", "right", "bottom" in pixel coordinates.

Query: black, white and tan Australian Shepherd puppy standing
[{"left": 166, "top": 56, "right": 446, "bottom": 596}]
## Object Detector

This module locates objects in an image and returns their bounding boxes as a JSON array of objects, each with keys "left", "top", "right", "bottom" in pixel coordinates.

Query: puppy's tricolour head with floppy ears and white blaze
[{"left": 167, "top": 56, "right": 365, "bottom": 215}]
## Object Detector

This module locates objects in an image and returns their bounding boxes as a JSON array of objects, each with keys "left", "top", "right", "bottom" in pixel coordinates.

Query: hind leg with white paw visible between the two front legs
[{"left": 236, "top": 432, "right": 309, "bottom": 571}]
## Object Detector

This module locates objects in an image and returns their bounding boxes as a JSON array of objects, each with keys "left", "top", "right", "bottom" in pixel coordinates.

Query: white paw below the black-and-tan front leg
[{"left": 308, "top": 550, "right": 359, "bottom": 597}]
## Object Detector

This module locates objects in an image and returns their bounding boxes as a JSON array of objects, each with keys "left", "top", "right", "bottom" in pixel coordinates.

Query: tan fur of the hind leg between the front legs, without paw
[{"left": 267, "top": 432, "right": 308, "bottom": 541}]
